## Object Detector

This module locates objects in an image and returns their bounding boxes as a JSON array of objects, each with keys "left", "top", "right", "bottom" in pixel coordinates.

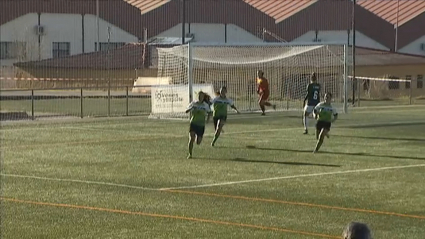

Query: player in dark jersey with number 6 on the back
[{"left": 303, "top": 72, "right": 322, "bottom": 134}]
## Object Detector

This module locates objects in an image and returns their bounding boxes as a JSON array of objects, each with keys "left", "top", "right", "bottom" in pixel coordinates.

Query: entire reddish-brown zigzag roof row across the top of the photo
[{"left": 0, "top": 0, "right": 425, "bottom": 53}]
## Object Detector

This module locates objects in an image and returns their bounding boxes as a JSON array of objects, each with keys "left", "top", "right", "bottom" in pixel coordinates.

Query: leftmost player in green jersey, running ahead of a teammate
[{"left": 186, "top": 91, "right": 211, "bottom": 159}]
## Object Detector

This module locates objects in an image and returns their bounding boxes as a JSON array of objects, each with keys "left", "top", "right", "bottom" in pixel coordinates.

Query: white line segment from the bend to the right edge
[{"left": 160, "top": 164, "right": 425, "bottom": 190}]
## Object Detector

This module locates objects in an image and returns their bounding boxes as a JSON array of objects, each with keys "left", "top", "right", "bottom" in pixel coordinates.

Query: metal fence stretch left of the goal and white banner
[{"left": 0, "top": 86, "right": 151, "bottom": 120}]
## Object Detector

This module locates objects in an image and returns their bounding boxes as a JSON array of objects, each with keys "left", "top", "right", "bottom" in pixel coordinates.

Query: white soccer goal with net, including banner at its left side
[{"left": 151, "top": 43, "right": 348, "bottom": 118}]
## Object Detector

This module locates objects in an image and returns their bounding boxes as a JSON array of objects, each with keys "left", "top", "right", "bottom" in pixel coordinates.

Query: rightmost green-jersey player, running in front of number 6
[{"left": 313, "top": 93, "right": 338, "bottom": 153}]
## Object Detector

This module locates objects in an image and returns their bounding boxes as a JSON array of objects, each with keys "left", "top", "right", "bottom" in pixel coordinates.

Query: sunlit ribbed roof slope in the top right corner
[{"left": 357, "top": 0, "right": 425, "bottom": 26}]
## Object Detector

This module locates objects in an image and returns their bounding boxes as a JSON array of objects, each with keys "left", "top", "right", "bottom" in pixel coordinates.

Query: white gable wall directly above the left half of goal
[{"left": 155, "top": 23, "right": 262, "bottom": 43}]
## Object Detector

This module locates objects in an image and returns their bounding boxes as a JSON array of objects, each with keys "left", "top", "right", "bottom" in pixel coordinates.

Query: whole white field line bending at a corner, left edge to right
[{"left": 0, "top": 164, "right": 425, "bottom": 191}]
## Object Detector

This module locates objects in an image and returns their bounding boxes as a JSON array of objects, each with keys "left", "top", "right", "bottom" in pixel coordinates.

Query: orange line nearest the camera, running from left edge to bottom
[{"left": 0, "top": 197, "right": 340, "bottom": 239}]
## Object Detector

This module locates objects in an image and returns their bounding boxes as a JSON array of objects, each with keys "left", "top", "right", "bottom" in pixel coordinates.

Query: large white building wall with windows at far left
[{"left": 0, "top": 13, "right": 138, "bottom": 66}]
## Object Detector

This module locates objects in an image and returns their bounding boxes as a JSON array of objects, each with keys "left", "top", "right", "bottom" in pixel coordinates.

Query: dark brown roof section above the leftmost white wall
[{"left": 0, "top": 0, "right": 143, "bottom": 38}]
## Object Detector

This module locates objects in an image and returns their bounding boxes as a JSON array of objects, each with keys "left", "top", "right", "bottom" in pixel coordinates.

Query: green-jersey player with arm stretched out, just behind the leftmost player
[{"left": 211, "top": 86, "right": 239, "bottom": 146}]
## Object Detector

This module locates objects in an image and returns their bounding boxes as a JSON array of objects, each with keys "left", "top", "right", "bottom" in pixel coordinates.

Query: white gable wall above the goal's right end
[{"left": 293, "top": 31, "right": 390, "bottom": 50}]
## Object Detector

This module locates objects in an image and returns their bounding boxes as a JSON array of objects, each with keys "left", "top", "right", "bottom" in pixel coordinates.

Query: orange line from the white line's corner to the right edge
[{"left": 163, "top": 190, "right": 425, "bottom": 220}]
